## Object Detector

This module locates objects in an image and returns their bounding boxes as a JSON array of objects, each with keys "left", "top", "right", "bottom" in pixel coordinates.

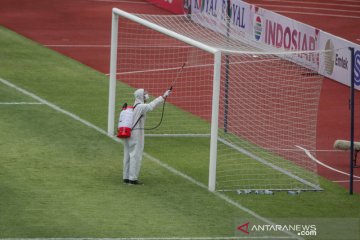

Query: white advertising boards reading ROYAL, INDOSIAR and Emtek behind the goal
[{"left": 189, "top": 0, "right": 360, "bottom": 90}]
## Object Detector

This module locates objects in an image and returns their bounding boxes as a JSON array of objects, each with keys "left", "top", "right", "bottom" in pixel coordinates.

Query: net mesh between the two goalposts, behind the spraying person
[{"left": 117, "top": 16, "right": 214, "bottom": 134}]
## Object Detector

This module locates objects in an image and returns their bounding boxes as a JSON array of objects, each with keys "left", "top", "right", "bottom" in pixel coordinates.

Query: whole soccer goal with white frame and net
[{"left": 108, "top": 9, "right": 322, "bottom": 191}]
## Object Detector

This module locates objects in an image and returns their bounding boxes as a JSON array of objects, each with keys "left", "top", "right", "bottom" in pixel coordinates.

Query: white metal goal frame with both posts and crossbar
[{"left": 107, "top": 8, "right": 322, "bottom": 191}]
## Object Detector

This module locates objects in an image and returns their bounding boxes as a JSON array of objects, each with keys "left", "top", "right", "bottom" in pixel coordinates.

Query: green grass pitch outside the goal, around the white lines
[{"left": 0, "top": 28, "right": 360, "bottom": 238}]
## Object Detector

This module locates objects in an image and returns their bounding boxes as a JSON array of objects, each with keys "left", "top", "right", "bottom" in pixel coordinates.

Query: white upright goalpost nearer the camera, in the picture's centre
[{"left": 209, "top": 51, "right": 221, "bottom": 192}]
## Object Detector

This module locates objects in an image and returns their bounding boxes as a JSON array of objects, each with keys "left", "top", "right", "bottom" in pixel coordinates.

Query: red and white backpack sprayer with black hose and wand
[{"left": 117, "top": 63, "right": 186, "bottom": 138}]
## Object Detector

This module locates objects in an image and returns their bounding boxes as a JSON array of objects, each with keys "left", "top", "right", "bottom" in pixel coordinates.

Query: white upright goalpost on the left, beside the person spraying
[{"left": 108, "top": 9, "right": 119, "bottom": 136}]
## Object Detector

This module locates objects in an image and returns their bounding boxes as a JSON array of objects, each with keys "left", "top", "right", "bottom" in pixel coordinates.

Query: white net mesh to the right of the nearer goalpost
[{"left": 217, "top": 54, "right": 322, "bottom": 190}]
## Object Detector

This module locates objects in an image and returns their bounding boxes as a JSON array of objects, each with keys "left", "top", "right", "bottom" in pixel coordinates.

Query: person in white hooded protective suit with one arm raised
[{"left": 123, "top": 88, "right": 171, "bottom": 184}]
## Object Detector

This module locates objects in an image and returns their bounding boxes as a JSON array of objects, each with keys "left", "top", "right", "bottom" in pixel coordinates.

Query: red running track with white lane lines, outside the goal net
[{"left": 0, "top": 0, "right": 360, "bottom": 192}]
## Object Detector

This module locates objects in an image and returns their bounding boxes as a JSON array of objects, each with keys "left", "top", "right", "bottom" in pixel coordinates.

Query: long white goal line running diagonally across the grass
[{"left": 0, "top": 78, "right": 303, "bottom": 239}]
